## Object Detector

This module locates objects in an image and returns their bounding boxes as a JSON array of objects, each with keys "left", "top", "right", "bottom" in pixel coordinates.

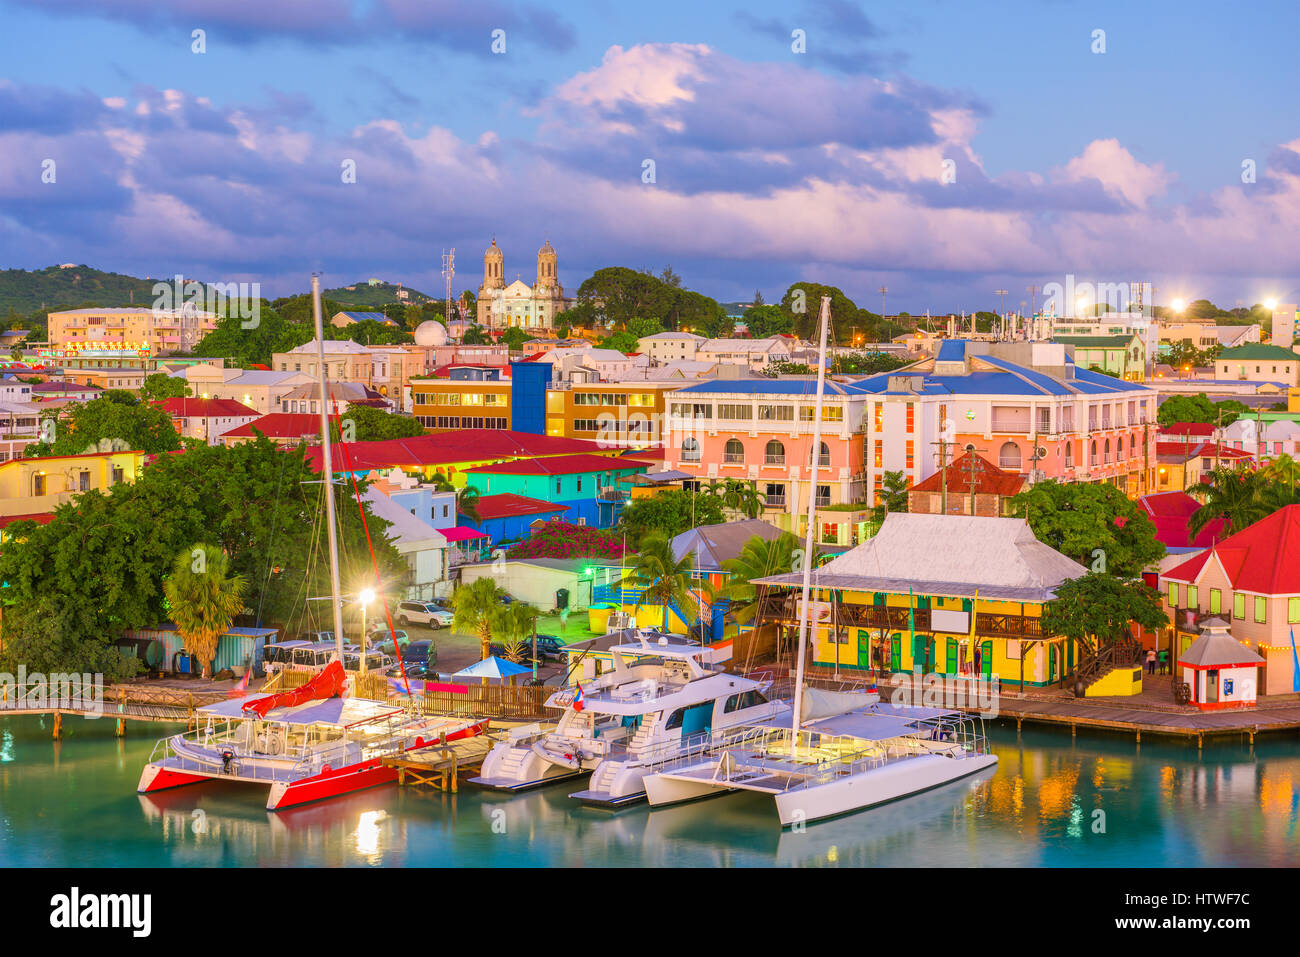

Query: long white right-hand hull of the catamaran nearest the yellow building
[{"left": 776, "top": 754, "right": 997, "bottom": 827}]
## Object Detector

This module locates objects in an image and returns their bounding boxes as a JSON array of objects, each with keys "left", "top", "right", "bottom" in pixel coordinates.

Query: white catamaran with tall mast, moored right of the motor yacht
[{"left": 642, "top": 296, "right": 997, "bottom": 827}]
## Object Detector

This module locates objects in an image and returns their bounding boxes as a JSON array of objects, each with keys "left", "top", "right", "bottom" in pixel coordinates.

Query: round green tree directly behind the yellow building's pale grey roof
[{"left": 1011, "top": 481, "right": 1165, "bottom": 577}]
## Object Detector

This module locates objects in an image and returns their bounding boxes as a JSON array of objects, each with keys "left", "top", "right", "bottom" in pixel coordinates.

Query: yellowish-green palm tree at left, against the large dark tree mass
[{"left": 163, "top": 542, "right": 248, "bottom": 677}]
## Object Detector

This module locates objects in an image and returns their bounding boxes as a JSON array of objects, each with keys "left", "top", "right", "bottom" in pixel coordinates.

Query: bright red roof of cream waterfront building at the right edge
[{"left": 1161, "top": 505, "right": 1300, "bottom": 594}]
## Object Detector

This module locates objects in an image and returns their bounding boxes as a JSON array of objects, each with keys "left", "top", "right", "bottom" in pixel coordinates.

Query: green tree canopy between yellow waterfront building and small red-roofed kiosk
[{"left": 1043, "top": 572, "right": 1169, "bottom": 660}]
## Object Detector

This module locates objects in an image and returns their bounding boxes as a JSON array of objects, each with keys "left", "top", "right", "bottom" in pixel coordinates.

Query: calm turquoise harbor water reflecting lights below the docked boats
[{"left": 0, "top": 718, "right": 1300, "bottom": 867}]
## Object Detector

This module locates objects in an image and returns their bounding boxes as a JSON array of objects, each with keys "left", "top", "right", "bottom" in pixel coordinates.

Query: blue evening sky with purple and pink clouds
[{"left": 0, "top": 0, "right": 1300, "bottom": 313}]
